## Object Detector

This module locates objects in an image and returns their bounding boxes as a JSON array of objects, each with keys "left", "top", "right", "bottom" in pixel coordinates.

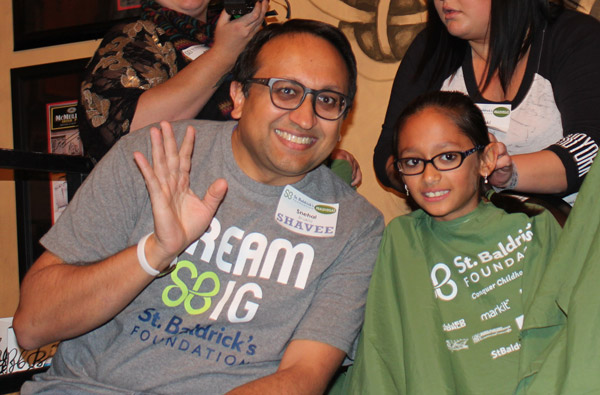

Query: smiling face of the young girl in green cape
[{"left": 398, "top": 107, "right": 493, "bottom": 221}]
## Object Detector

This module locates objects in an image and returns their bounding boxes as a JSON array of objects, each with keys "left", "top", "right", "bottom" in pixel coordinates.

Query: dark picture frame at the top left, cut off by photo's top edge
[{"left": 13, "top": 0, "right": 140, "bottom": 51}]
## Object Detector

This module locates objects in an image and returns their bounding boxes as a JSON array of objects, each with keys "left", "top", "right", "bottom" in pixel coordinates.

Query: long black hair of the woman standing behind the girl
[{"left": 415, "top": 0, "right": 578, "bottom": 92}]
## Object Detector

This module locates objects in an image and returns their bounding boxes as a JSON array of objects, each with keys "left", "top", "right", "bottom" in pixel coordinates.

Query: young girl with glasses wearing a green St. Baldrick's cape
[{"left": 346, "top": 92, "right": 560, "bottom": 394}]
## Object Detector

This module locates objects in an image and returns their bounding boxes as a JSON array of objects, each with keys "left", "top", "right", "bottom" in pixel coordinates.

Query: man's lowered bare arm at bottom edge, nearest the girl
[{"left": 229, "top": 340, "right": 346, "bottom": 395}]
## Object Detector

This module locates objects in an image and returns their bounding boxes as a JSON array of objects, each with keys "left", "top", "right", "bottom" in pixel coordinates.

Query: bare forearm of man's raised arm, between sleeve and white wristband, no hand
[{"left": 13, "top": 247, "right": 154, "bottom": 349}]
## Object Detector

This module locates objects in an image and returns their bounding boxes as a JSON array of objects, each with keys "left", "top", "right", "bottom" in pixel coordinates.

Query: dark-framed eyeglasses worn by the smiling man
[{"left": 246, "top": 78, "right": 348, "bottom": 121}]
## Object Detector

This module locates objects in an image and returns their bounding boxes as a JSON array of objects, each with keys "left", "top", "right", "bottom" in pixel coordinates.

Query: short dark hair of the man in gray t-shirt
[{"left": 232, "top": 19, "right": 357, "bottom": 113}]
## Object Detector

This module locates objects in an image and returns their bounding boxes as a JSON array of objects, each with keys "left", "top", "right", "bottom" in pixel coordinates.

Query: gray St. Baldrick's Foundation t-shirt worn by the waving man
[{"left": 22, "top": 121, "right": 383, "bottom": 394}]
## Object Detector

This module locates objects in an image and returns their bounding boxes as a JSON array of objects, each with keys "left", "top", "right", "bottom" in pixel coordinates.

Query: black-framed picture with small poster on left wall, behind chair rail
[{"left": 11, "top": 59, "right": 92, "bottom": 279}]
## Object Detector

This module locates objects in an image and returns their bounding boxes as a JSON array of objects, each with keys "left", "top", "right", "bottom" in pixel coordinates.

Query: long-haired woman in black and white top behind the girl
[{"left": 374, "top": 0, "right": 600, "bottom": 204}]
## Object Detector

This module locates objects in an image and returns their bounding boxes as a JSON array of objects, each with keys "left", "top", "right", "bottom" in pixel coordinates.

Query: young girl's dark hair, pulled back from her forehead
[{"left": 393, "top": 91, "right": 543, "bottom": 217}]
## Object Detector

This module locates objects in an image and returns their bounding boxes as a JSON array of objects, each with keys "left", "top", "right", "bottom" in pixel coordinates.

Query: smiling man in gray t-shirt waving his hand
[{"left": 14, "top": 20, "right": 383, "bottom": 394}]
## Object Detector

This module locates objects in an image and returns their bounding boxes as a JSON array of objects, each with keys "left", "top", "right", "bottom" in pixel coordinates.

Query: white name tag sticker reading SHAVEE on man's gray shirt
[{"left": 275, "top": 185, "right": 340, "bottom": 237}]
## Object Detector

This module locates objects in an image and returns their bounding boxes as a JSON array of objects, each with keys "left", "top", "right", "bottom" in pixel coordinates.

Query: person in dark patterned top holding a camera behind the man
[{"left": 79, "top": 0, "right": 269, "bottom": 160}]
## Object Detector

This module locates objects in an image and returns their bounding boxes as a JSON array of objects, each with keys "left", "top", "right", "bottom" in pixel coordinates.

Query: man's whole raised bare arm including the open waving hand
[{"left": 13, "top": 122, "right": 227, "bottom": 348}]
